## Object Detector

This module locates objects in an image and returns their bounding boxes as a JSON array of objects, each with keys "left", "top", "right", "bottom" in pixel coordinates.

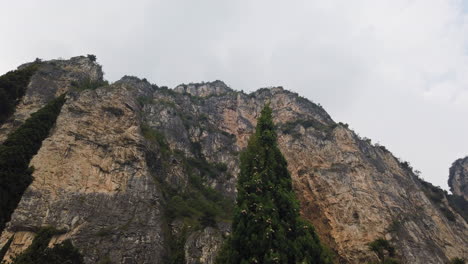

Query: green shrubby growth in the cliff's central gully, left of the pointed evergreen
[{"left": 142, "top": 129, "right": 234, "bottom": 264}]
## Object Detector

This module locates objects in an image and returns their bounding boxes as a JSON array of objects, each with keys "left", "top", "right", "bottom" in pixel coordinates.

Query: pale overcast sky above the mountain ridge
[{"left": 0, "top": 0, "right": 468, "bottom": 189}]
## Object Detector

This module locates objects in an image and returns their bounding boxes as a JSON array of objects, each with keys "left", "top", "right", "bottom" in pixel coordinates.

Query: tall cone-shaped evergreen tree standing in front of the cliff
[{"left": 217, "top": 105, "right": 332, "bottom": 264}]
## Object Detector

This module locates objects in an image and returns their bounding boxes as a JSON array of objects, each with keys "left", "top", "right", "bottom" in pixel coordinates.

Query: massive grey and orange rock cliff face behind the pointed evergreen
[{"left": 0, "top": 56, "right": 468, "bottom": 264}]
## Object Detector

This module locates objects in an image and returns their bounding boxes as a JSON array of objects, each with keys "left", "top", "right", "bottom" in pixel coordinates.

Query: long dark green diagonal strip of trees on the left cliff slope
[{"left": 0, "top": 95, "right": 65, "bottom": 232}]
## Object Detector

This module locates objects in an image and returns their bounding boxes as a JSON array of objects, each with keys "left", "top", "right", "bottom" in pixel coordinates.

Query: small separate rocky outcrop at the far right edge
[{"left": 448, "top": 157, "right": 468, "bottom": 200}]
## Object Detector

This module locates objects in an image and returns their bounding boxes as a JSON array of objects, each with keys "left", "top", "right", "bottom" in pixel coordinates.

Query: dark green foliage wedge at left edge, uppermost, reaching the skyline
[{"left": 0, "top": 62, "right": 40, "bottom": 125}]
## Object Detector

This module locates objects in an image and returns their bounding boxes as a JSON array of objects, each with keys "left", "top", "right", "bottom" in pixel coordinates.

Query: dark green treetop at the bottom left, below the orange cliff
[{"left": 12, "top": 227, "right": 83, "bottom": 264}]
